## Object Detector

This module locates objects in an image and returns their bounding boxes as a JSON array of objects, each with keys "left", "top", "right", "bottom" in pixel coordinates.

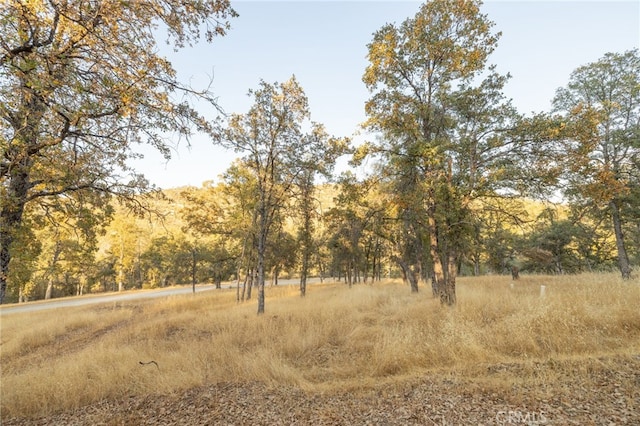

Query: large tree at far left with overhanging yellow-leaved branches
[{"left": 0, "top": 0, "right": 235, "bottom": 302}]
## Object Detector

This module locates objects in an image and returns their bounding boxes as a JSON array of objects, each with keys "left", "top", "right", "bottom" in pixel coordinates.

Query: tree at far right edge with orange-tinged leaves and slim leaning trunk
[{"left": 554, "top": 49, "right": 640, "bottom": 279}]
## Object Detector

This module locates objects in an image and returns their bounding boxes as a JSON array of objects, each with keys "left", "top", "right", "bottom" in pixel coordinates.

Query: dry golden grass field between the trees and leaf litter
[{"left": 0, "top": 274, "right": 640, "bottom": 418}]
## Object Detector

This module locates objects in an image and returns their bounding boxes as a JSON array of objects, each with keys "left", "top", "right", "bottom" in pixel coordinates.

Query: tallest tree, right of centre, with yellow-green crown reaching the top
[{"left": 363, "top": 0, "right": 514, "bottom": 305}]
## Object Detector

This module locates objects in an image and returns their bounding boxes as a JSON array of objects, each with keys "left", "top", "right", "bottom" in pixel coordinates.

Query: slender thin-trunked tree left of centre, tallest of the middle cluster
[{"left": 219, "top": 77, "right": 341, "bottom": 314}]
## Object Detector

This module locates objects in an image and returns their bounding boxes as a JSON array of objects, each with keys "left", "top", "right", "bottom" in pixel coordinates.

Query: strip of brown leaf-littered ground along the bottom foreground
[{"left": 2, "top": 356, "right": 640, "bottom": 426}]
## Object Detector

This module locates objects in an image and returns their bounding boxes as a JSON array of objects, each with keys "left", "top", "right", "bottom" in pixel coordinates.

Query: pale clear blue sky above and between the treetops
[{"left": 134, "top": 0, "right": 640, "bottom": 188}]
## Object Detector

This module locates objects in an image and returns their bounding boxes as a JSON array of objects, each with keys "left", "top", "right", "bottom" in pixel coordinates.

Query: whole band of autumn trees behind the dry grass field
[{"left": 0, "top": 0, "right": 640, "bottom": 313}]
